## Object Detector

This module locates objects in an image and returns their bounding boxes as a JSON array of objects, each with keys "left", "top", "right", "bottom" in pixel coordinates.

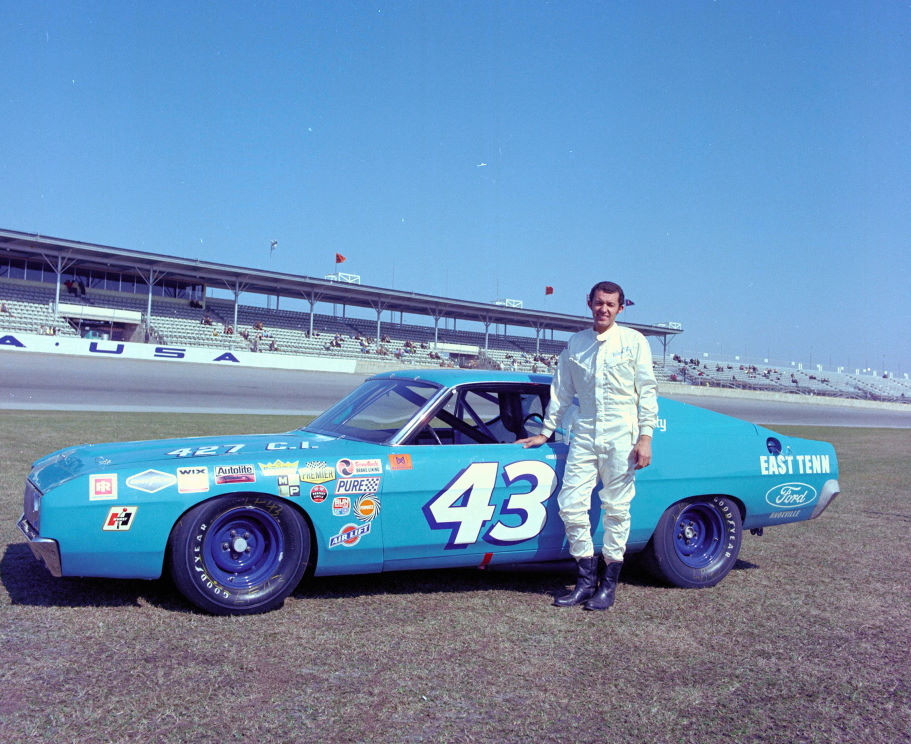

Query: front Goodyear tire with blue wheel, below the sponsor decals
[{"left": 168, "top": 494, "right": 310, "bottom": 615}]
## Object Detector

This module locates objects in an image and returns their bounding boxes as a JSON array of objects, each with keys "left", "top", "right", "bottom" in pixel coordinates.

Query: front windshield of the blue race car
[{"left": 304, "top": 379, "right": 440, "bottom": 442}]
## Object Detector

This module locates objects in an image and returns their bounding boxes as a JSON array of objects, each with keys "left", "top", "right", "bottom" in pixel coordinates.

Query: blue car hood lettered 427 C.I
[{"left": 29, "top": 431, "right": 337, "bottom": 491}]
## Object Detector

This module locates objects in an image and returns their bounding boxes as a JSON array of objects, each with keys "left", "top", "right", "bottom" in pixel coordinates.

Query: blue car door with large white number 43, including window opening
[{"left": 382, "top": 384, "right": 566, "bottom": 569}]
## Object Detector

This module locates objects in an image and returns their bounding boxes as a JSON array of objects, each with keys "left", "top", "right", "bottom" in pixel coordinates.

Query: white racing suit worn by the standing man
[{"left": 541, "top": 324, "right": 658, "bottom": 563}]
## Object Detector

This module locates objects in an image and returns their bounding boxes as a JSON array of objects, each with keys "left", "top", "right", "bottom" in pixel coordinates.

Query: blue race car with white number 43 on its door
[{"left": 19, "top": 369, "right": 839, "bottom": 614}]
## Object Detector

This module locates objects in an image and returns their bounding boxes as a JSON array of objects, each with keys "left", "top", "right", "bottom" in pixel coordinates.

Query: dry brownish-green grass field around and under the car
[{"left": 0, "top": 412, "right": 911, "bottom": 744}]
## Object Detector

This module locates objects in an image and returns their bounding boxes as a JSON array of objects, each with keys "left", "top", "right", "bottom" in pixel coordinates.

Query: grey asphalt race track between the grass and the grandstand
[{"left": 0, "top": 350, "right": 911, "bottom": 428}]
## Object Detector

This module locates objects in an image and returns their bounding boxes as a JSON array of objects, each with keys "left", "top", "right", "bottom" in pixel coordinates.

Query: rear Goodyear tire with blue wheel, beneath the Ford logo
[{"left": 642, "top": 496, "right": 743, "bottom": 589}]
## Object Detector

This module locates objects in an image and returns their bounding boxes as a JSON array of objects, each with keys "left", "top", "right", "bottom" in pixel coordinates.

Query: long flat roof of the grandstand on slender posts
[{"left": 0, "top": 229, "right": 682, "bottom": 343}]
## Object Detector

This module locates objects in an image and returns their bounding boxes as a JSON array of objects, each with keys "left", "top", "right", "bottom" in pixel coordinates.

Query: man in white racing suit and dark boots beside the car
[{"left": 519, "top": 282, "right": 658, "bottom": 610}]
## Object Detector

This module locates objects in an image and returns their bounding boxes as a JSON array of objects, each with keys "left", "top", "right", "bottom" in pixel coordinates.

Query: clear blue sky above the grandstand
[{"left": 0, "top": 0, "right": 911, "bottom": 373}]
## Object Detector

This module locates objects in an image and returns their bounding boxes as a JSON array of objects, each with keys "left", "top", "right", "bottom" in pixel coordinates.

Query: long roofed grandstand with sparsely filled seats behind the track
[{"left": 0, "top": 230, "right": 911, "bottom": 402}]
